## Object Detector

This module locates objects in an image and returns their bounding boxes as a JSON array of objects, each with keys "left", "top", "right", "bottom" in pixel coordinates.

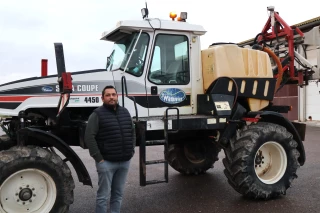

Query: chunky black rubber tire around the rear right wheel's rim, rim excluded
[{"left": 223, "top": 122, "right": 299, "bottom": 199}]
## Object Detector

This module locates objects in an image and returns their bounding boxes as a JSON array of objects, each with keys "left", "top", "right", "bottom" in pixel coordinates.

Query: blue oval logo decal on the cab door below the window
[{"left": 159, "top": 88, "right": 186, "bottom": 104}]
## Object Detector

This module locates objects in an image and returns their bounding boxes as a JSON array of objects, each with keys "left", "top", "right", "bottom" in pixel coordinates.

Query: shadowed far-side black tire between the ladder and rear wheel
[{"left": 168, "top": 140, "right": 221, "bottom": 175}]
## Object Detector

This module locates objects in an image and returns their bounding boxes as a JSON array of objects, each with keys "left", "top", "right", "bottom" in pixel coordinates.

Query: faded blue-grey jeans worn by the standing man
[{"left": 96, "top": 160, "right": 131, "bottom": 213}]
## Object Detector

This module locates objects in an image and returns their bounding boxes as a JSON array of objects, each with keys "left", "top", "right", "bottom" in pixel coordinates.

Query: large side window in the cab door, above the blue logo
[{"left": 149, "top": 34, "right": 190, "bottom": 85}]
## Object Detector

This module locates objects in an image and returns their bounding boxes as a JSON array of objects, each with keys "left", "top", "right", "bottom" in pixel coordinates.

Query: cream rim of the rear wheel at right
[{"left": 254, "top": 141, "right": 287, "bottom": 184}]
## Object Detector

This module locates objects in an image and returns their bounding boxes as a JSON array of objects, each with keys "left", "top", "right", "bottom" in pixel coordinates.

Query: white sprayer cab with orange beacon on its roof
[{"left": 101, "top": 12, "right": 206, "bottom": 116}]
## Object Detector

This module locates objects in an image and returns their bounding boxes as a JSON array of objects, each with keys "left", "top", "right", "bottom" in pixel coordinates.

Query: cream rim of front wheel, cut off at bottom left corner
[{"left": 0, "top": 169, "right": 57, "bottom": 213}]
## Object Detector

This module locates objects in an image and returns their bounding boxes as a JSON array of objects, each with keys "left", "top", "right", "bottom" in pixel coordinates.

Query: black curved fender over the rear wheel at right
[{"left": 248, "top": 111, "right": 306, "bottom": 166}]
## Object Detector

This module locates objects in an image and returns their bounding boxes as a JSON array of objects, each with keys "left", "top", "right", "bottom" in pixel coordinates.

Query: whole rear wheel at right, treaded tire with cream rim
[{"left": 223, "top": 122, "right": 300, "bottom": 200}]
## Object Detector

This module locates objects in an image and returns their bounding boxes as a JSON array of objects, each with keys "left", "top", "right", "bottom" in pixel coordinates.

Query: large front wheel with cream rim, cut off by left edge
[{"left": 0, "top": 146, "right": 75, "bottom": 213}]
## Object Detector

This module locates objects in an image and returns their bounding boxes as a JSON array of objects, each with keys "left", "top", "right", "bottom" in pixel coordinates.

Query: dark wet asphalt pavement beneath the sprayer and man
[{"left": 70, "top": 126, "right": 320, "bottom": 213}]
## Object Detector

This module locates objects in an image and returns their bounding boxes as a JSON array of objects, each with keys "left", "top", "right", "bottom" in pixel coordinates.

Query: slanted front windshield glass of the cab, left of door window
[{"left": 107, "top": 33, "right": 149, "bottom": 76}]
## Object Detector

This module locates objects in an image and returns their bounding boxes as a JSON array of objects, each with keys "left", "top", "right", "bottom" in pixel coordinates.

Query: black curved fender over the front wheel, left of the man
[{"left": 18, "top": 127, "right": 93, "bottom": 187}]
